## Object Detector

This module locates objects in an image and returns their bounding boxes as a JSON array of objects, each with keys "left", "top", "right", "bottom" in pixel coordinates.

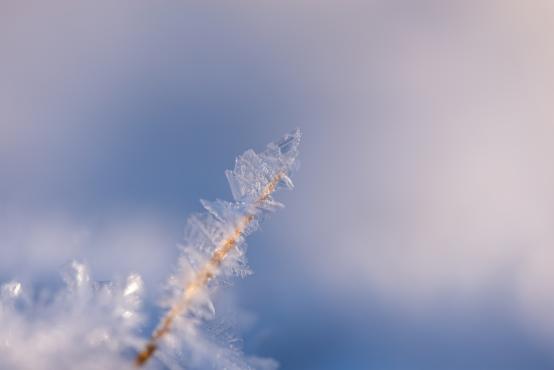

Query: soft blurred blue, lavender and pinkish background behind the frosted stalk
[{"left": 0, "top": 0, "right": 554, "bottom": 370}]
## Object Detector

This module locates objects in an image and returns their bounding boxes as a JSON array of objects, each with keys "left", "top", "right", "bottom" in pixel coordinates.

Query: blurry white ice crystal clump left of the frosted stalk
[{"left": 0, "top": 262, "right": 143, "bottom": 370}]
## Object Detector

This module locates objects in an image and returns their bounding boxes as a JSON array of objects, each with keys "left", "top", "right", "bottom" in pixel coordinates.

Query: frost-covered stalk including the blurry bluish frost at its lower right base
[{"left": 136, "top": 130, "right": 301, "bottom": 369}]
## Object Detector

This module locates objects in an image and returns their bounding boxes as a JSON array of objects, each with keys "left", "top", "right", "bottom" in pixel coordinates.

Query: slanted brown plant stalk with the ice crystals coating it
[{"left": 135, "top": 129, "right": 301, "bottom": 367}]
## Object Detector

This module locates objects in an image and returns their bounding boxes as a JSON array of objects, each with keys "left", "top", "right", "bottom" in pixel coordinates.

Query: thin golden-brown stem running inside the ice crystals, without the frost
[{"left": 135, "top": 174, "right": 283, "bottom": 367}]
